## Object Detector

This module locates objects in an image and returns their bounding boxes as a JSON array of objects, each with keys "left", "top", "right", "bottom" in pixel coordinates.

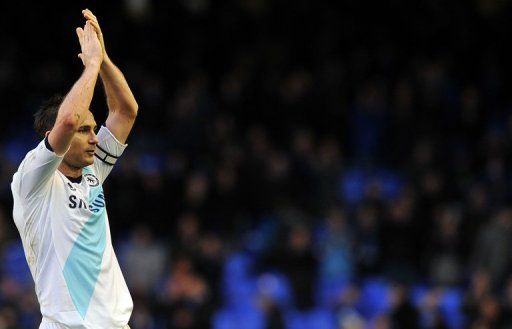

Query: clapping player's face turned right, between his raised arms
[{"left": 64, "top": 111, "right": 98, "bottom": 168}]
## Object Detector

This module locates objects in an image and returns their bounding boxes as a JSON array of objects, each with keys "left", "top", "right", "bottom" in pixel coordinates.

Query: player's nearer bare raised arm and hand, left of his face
[{"left": 48, "top": 22, "right": 103, "bottom": 155}]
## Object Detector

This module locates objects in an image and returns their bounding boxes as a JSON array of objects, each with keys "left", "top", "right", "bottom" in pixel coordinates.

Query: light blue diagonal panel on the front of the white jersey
[{"left": 63, "top": 168, "right": 106, "bottom": 318}]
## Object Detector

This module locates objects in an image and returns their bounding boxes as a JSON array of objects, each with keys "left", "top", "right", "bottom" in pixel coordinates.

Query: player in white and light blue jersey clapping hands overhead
[{"left": 11, "top": 10, "right": 138, "bottom": 329}]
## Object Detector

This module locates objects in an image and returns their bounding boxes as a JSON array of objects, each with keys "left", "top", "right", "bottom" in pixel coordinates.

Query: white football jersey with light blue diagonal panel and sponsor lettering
[{"left": 11, "top": 127, "right": 133, "bottom": 329}]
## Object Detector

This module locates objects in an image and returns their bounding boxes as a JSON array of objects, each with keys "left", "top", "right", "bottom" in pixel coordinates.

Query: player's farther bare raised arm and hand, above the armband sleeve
[{"left": 82, "top": 9, "right": 139, "bottom": 144}]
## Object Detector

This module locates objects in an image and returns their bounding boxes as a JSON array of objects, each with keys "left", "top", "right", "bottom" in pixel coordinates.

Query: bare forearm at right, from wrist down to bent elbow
[{"left": 100, "top": 57, "right": 138, "bottom": 118}]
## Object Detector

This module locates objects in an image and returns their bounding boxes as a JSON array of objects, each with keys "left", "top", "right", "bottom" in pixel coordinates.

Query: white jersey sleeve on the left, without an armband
[{"left": 13, "top": 139, "right": 64, "bottom": 198}]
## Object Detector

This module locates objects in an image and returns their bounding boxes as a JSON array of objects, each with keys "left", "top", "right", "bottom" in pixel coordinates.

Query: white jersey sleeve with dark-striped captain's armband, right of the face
[{"left": 92, "top": 126, "right": 128, "bottom": 183}]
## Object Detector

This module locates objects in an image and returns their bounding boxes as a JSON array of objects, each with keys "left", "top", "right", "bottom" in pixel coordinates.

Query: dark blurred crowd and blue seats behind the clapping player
[{"left": 0, "top": 0, "right": 512, "bottom": 329}]
